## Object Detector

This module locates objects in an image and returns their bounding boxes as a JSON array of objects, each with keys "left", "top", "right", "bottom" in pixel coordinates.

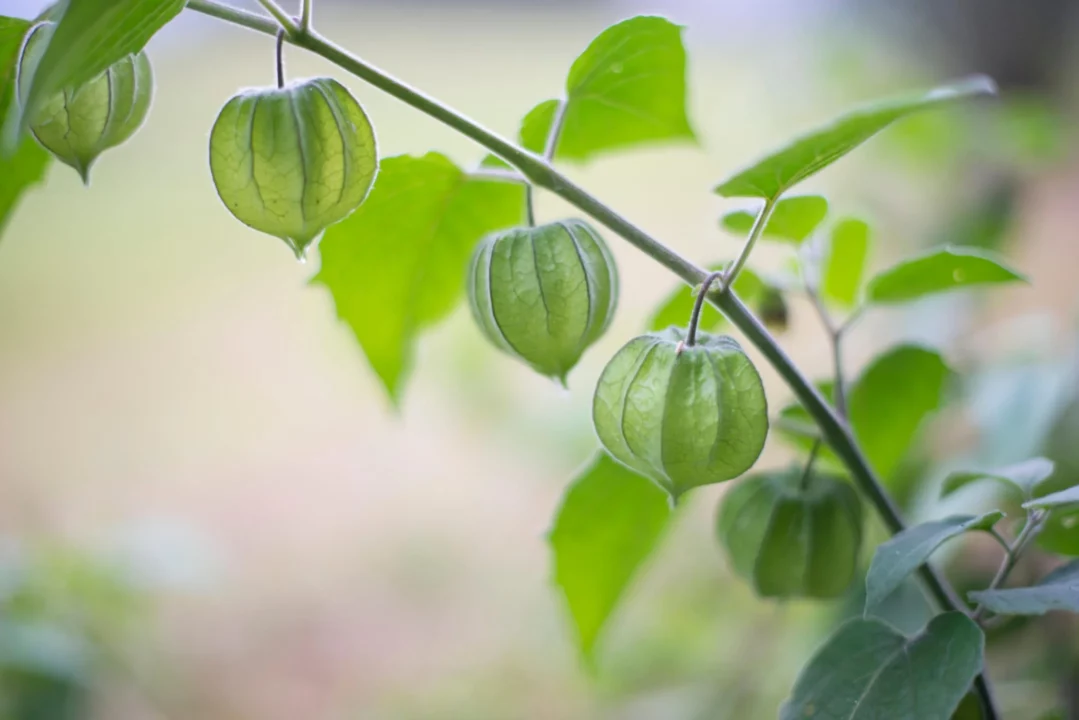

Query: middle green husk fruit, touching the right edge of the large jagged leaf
[{"left": 467, "top": 220, "right": 618, "bottom": 384}]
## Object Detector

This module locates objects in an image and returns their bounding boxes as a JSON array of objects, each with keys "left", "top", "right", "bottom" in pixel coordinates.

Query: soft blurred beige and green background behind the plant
[{"left": 0, "top": 0, "right": 1079, "bottom": 720}]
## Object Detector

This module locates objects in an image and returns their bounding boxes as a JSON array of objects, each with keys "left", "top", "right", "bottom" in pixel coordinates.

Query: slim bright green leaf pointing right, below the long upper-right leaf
[{"left": 865, "top": 247, "right": 1028, "bottom": 304}]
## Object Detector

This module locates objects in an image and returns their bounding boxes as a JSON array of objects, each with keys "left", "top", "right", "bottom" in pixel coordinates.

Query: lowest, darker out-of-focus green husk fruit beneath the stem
[{"left": 716, "top": 467, "right": 862, "bottom": 598}]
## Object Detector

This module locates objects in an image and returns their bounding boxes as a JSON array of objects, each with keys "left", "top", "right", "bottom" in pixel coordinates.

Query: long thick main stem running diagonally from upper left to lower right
[{"left": 188, "top": 0, "right": 999, "bottom": 720}]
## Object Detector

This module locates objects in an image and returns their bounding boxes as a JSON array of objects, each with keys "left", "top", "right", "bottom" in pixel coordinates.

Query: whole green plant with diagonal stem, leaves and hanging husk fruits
[{"left": 0, "top": 0, "right": 1079, "bottom": 719}]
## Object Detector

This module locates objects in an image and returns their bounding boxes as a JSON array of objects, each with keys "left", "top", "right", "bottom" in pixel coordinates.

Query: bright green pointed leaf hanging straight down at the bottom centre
[{"left": 548, "top": 452, "right": 671, "bottom": 662}]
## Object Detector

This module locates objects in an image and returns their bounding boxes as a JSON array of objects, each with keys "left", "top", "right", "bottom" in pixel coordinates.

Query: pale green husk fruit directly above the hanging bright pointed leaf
[{"left": 592, "top": 327, "right": 768, "bottom": 499}]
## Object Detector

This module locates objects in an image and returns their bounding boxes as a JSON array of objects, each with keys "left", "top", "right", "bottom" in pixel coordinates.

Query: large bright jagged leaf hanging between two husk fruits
[{"left": 314, "top": 152, "right": 523, "bottom": 403}]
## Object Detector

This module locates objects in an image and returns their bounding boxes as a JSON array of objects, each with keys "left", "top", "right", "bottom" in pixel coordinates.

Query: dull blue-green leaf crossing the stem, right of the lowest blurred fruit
[{"left": 865, "top": 511, "right": 1005, "bottom": 614}]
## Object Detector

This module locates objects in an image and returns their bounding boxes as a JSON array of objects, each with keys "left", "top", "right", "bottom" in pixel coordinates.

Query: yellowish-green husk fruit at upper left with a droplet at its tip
[{"left": 209, "top": 78, "right": 379, "bottom": 258}]
